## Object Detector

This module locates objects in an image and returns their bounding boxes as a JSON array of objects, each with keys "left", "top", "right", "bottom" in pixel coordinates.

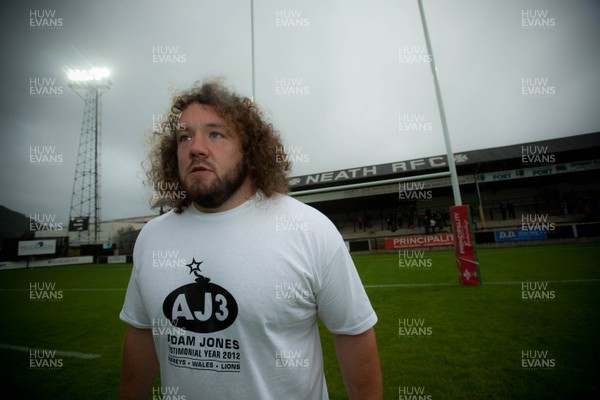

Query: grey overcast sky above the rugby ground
[{"left": 0, "top": 0, "right": 600, "bottom": 222}]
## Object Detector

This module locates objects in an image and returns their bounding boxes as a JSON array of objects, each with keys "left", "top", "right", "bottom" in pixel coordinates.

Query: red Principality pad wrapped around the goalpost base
[{"left": 450, "top": 205, "right": 481, "bottom": 285}]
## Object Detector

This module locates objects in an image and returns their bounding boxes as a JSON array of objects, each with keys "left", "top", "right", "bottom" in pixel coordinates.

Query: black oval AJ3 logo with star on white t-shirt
[{"left": 163, "top": 258, "right": 238, "bottom": 333}]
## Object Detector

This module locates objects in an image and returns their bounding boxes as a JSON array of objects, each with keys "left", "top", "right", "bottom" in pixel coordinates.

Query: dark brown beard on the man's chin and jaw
[{"left": 180, "top": 161, "right": 248, "bottom": 209}]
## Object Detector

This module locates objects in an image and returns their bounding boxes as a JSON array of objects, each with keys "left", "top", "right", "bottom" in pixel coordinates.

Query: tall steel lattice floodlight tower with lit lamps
[{"left": 68, "top": 68, "right": 112, "bottom": 245}]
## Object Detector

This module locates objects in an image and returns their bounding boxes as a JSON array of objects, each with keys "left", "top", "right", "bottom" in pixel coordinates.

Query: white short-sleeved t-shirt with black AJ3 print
[{"left": 120, "top": 193, "right": 377, "bottom": 400}]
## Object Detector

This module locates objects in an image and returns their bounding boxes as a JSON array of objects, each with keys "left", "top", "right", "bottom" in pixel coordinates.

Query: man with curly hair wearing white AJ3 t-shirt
[{"left": 120, "top": 81, "right": 382, "bottom": 400}]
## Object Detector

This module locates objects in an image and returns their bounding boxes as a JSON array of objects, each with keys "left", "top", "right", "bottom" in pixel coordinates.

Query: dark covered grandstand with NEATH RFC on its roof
[{"left": 290, "top": 132, "right": 600, "bottom": 249}]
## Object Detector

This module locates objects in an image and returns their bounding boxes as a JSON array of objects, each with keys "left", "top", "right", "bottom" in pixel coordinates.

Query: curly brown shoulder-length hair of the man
[{"left": 146, "top": 79, "right": 291, "bottom": 213}]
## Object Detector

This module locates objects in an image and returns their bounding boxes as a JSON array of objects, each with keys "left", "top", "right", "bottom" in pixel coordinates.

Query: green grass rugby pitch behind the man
[{"left": 0, "top": 243, "right": 600, "bottom": 400}]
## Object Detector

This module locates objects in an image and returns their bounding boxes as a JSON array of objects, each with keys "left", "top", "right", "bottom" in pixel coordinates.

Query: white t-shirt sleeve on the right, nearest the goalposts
[{"left": 316, "top": 242, "right": 377, "bottom": 335}]
